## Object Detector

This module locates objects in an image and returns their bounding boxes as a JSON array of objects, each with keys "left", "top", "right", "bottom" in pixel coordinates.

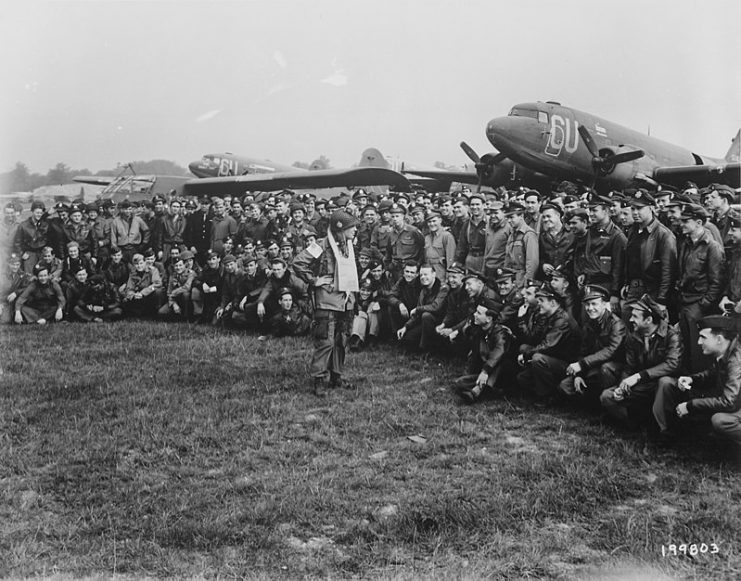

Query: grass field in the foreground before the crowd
[{"left": 0, "top": 322, "right": 741, "bottom": 579}]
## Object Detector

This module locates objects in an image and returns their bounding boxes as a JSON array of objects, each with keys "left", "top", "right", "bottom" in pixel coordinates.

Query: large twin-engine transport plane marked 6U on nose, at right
[{"left": 405, "top": 101, "right": 741, "bottom": 190}]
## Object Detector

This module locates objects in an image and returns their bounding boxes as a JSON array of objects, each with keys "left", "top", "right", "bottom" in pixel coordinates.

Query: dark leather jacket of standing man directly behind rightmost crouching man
[{"left": 677, "top": 231, "right": 724, "bottom": 310}]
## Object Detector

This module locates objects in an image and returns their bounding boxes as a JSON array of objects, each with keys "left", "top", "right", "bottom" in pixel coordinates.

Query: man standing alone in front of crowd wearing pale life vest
[{"left": 293, "top": 210, "right": 359, "bottom": 396}]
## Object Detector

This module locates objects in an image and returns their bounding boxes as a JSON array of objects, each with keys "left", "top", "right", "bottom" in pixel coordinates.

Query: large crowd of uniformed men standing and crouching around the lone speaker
[{"left": 0, "top": 183, "right": 741, "bottom": 458}]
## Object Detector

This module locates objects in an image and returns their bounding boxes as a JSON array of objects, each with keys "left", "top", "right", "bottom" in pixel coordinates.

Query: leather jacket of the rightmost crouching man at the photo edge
[{"left": 687, "top": 339, "right": 741, "bottom": 413}]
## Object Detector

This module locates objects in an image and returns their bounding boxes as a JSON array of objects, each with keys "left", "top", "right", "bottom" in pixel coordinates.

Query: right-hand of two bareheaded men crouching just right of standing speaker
[{"left": 396, "top": 264, "right": 449, "bottom": 353}]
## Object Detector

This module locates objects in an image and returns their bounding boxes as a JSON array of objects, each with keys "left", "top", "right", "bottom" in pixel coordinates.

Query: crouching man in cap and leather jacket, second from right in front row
[{"left": 600, "top": 294, "right": 682, "bottom": 427}]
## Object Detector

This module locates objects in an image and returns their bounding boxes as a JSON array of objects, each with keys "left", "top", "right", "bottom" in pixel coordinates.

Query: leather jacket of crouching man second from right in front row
[{"left": 625, "top": 320, "right": 682, "bottom": 390}]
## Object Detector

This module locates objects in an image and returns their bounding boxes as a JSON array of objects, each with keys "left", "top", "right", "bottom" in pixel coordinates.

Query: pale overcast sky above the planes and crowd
[{"left": 0, "top": 0, "right": 741, "bottom": 173}]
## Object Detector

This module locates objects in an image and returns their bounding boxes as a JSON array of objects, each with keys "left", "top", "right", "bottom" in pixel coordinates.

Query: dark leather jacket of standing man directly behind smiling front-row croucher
[{"left": 573, "top": 221, "right": 628, "bottom": 296}]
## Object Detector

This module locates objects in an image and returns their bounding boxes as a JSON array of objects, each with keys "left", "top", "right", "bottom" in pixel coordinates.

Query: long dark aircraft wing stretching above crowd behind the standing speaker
[{"left": 185, "top": 167, "right": 411, "bottom": 196}]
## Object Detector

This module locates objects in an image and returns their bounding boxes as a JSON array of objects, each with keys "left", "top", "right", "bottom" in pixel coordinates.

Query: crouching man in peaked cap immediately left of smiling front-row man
[{"left": 517, "top": 285, "right": 580, "bottom": 408}]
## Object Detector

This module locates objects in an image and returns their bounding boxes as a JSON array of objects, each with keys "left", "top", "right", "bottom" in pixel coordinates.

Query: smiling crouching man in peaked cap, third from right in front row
[{"left": 558, "top": 285, "right": 626, "bottom": 403}]
